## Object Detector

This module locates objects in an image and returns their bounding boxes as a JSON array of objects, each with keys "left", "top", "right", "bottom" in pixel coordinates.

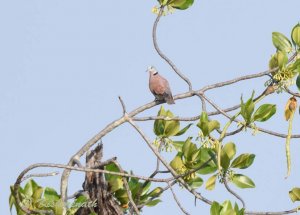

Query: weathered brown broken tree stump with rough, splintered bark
[{"left": 75, "top": 144, "right": 123, "bottom": 215}]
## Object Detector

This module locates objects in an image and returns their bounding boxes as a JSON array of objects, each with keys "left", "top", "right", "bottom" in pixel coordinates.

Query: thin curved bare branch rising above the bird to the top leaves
[{"left": 152, "top": 6, "right": 193, "bottom": 91}]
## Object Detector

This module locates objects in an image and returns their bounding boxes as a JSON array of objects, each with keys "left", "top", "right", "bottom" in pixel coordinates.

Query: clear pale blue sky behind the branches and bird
[{"left": 0, "top": 0, "right": 300, "bottom": 215}]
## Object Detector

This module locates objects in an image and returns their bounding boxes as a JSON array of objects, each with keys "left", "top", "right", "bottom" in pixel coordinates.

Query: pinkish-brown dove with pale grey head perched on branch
[{"left": 147, "top": 66, "right": 175, "bottom": 104}]
